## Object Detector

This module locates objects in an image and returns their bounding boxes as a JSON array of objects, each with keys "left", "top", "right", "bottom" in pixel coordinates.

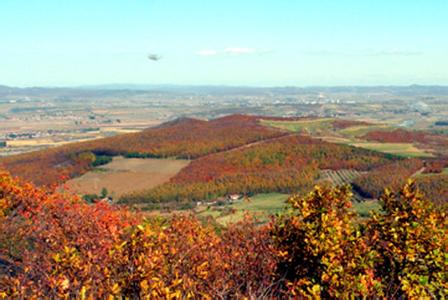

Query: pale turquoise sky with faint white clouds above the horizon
[{"left": 0, "top": 0, "right": 448, "bottom": 87}]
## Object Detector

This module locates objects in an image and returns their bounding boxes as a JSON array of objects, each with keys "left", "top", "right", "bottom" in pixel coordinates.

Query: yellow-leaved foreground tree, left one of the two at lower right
[{"left": 271, "top": 187, "right": 378, "bottom": 298}]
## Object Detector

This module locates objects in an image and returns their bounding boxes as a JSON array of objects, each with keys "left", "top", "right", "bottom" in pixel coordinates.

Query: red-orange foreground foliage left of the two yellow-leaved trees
[{"left": 0, "top": 173, "right": 275, "bottom": 299}]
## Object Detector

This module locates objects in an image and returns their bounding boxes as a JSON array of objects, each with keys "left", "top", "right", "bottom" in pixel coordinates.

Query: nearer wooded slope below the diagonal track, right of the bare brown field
[{"left": 122, "top": 135, "right": 398, "bottom": 203}]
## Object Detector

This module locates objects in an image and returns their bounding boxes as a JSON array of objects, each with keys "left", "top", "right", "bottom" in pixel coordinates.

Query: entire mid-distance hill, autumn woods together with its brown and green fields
[{"left": 0, "top": 115, "right": 448, "bottom": 224}]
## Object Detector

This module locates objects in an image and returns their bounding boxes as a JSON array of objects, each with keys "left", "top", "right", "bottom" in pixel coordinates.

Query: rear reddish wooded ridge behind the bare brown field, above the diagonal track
[{"left": 0, "top": 115, "right": 286, "bottom": 185}]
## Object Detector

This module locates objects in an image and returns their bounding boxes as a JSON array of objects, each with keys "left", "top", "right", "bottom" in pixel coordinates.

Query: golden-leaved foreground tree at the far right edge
[{"left": 366, "top": 181, "right": 448, "bottom": 299}]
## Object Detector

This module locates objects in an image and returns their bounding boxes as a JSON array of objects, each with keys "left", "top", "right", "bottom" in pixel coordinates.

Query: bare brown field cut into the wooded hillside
[{"left": 66, "top": 157, "right": 189, "bottom": 199}]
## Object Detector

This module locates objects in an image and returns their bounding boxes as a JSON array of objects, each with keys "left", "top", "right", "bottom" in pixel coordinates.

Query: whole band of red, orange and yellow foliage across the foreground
[{"left": 0, "top": 174, "right": 448, "bottom": 299}]
